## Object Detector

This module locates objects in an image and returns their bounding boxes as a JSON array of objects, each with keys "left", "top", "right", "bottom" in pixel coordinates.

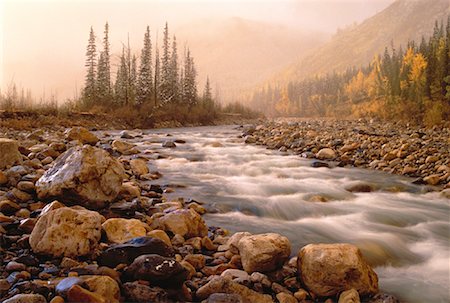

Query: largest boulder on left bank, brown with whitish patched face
[{"left": 36, "top": 145, "right": 124, "bottom": 209}]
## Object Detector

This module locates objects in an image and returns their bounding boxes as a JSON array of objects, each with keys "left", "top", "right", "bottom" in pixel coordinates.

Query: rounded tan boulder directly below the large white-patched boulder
[{"left": 29, "top": 206, "right": 105, "bottom": 257}]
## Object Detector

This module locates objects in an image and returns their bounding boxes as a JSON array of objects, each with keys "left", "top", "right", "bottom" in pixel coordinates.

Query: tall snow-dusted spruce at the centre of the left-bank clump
[{"left": 136, "top": 26, "right": 153, "bottom": 104}]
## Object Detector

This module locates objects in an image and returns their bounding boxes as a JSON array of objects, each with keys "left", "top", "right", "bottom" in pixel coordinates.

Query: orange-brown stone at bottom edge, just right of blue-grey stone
[{"left": 80, "top": 275, "right": 120, "bottom": 303}]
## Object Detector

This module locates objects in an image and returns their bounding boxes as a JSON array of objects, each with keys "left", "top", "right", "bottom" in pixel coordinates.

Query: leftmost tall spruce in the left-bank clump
[{"left": 83, "top": 26, "right": 97, "bottom": 108}]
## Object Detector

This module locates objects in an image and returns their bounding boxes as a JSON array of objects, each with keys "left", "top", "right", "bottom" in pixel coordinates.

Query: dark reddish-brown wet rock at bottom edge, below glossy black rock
[{"left": 123, "top": 282, "right": 168, "bottom": 303}]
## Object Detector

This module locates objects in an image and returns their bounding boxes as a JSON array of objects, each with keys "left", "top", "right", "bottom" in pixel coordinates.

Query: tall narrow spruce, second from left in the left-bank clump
[{"left": 97, "top": 23, "right": 112, "bottom": 105}]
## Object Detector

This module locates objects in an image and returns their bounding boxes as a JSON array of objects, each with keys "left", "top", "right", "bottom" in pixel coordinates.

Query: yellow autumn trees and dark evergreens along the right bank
[{"left": 250, "top": 16, "right": 450, "bottom": 125}]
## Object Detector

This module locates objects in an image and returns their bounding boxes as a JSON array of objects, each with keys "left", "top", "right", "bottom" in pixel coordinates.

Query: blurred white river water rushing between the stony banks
[{"left": 118, "top": 126, "right": 450, "bottom": 302}]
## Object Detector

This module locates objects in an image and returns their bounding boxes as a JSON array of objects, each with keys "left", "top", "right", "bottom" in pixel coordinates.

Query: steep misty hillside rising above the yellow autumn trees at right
[{"left": 271, "top": 0, "right": 450, "bottom": 83}]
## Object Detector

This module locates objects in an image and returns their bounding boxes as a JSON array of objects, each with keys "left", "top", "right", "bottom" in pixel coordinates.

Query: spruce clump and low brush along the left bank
[{"left": 0, "top": 23, "right": 259, "bottom": 126}]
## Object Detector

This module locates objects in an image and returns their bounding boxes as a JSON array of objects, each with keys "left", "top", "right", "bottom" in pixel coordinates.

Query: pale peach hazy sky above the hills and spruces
[{"left": 0, "top": 0, "right": 394, "bottom": 98}]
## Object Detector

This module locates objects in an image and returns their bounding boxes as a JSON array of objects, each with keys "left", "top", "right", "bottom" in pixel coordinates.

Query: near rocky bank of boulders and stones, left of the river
[{"left": 0, "top": 127, "right": 400, "bottom": 303}]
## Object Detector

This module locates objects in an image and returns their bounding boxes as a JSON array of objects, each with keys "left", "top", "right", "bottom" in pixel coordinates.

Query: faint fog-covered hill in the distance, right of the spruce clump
[{"left": 176, "top": 17, "right": 327, "bottom": 100}]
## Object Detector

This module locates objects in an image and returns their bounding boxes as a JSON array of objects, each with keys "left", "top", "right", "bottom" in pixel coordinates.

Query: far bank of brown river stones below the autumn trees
[{"left": 244, "top": 120, "right": 450, "bottom": 190}]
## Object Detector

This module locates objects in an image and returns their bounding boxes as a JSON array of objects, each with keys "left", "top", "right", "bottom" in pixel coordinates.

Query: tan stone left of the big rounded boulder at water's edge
[{"left": 238, "top": 233, "right": 291, "bottom": 273}]
